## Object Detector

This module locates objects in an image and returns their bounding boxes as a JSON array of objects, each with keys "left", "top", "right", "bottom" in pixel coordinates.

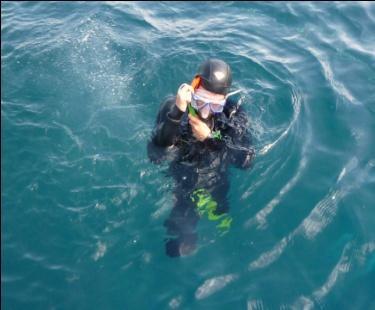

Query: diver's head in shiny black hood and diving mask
[{"left": 192, "top": 58, "right": 232, "bottom": 119}]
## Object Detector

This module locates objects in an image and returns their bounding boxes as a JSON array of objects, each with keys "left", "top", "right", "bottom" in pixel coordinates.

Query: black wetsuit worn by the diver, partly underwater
[{"left": 148, "top": 97, "right": 254, "bottom": 256}]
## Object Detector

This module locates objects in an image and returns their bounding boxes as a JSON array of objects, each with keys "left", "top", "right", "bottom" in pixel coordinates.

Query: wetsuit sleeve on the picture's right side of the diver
[{"left": 226, "top": 107, "right": 255, "bottom": 169}]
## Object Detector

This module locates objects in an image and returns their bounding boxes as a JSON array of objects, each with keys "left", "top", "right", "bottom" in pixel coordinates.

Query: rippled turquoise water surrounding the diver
[{"left": 1, "top": 2, "right": 375, "bottom": 309}]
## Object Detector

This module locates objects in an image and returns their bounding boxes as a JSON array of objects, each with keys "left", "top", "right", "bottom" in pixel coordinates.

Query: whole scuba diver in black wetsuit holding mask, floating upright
[{"left": 148, "top": 59, "right": 254, "bottom": 257}]
